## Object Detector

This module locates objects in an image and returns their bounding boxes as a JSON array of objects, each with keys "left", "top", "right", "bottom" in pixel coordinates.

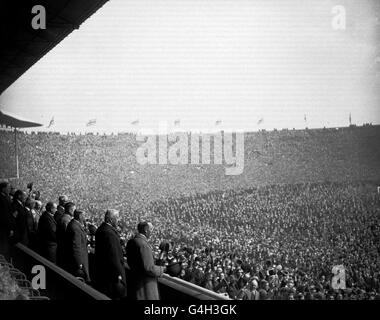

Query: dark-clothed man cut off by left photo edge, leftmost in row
[{"left": 0, "top": 182, "right": 14, "bottom": 258}]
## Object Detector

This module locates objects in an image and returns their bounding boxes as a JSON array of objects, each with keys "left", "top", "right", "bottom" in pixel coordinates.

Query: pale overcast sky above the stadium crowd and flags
[{"left": 0, "top": 0, "right": 380, "bottom": 132}]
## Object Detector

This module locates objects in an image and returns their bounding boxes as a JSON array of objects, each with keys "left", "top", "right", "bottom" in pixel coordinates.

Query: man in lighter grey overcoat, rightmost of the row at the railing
[{"left": 126, "top": 222, "right": 166, "bottom": 300}]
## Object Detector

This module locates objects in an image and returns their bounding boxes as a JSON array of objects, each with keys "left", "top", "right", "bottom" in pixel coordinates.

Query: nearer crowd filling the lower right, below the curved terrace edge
[{"left": 3, "top": 182, "right": 380, "bottom": 300}]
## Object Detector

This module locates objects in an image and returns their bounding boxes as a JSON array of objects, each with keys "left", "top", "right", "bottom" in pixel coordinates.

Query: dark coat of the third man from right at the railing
[{"left": 65, "top": 219, "right": 90, "bottom": 281}]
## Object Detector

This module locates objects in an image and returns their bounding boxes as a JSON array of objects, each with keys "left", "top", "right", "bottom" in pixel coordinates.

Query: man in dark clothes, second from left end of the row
[{"left": 12, "top": 190, "right": 29, "bottom": 246}]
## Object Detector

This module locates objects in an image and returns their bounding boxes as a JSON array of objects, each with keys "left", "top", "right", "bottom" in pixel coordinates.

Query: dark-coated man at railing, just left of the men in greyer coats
[{"left": 37, "top": 202, "right": 57, "bottom": 263}]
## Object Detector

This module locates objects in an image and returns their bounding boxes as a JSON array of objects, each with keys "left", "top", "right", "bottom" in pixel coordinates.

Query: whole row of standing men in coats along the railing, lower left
[{"left": 0, "top": 182, "right": 166, "bottom": 300}]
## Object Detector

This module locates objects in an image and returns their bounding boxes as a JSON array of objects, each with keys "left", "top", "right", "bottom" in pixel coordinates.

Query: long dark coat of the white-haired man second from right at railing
[{"left": 94, "top": 222, "right": 126, "bottom": 299}]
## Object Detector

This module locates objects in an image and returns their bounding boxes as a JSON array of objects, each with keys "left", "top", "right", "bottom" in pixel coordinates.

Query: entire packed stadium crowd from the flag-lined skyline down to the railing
[{"left": 0, "top": 126, "right": 380, "bottom": 300}]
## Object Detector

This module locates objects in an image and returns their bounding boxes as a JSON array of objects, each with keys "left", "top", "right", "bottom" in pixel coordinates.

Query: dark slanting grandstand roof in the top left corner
[{"left": 0, "top": 0, "right": 108, "bottom": 94}]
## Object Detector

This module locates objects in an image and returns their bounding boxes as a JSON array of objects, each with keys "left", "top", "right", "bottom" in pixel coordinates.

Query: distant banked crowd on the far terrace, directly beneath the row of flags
[{"left": 0, "top": 126, "right": 380, "bottom": 213}]
